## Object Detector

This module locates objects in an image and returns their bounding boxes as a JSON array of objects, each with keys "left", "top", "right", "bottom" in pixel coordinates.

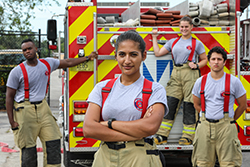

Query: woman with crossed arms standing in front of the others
[{"left": 83, "top": 30, "right": 168, "bottom": 167}]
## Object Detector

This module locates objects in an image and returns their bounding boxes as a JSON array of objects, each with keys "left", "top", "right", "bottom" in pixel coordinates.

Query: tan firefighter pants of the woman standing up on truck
[{"left": 157, "top": 63, "right": 199, "bottom": 140}]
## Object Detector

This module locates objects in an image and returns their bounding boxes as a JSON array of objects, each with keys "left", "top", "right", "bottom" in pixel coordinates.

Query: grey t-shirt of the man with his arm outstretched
[{"left": 6, "top": 58, "right": 60, "bottom": 102}]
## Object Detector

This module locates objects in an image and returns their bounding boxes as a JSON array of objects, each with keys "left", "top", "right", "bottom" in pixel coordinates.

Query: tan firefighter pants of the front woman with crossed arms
[{"left": 92, "top": 140, "right": 162, "bottom": 167}]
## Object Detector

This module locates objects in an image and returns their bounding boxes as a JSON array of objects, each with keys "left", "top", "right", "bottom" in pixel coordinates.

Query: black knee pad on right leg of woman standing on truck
[{"left": 183, "top": 102, "right": 196, "bottom": 125}]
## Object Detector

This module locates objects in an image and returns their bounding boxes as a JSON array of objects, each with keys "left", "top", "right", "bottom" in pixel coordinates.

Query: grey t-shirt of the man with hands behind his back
[{"left": 192, "top": 73, "right": 246, "bottom": 119}]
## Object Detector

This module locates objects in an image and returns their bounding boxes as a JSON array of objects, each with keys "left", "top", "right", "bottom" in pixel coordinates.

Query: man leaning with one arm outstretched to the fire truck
[{"left": 6, "top": 39, "right": 97, "bottom": 167}]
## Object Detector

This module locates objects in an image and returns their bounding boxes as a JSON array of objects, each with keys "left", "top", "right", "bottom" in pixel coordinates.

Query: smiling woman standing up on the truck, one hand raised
[{"left": 152, "top": 16, "right": 207, "bottom": 145}]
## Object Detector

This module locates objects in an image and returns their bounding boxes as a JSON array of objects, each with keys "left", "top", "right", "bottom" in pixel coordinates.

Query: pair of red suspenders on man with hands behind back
[{"left": 200, "top": 74, "right": 231, "bottom": 113}]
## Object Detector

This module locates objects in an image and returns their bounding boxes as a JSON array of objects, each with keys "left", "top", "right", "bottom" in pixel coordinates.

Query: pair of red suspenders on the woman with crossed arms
[{"left": 101, "top": 78, "right": 153, "bottom": 120}]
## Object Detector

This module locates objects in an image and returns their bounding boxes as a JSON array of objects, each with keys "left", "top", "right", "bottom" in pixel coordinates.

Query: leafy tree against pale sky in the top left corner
[{"left": 0, "top": 0, "right": 60, "bottom": 31}]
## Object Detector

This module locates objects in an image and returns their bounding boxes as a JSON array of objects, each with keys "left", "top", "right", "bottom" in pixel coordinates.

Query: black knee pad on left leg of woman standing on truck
[{"left": 164, "top": 96, "right": 180, "bottom": 120}]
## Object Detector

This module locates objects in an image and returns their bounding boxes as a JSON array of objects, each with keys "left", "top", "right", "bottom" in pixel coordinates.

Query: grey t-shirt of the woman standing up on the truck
[{"left": 164, "top": 37, "right": 205, "bottom": 64}]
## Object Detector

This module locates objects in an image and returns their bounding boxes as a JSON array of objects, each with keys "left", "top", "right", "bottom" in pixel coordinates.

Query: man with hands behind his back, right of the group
[{"left": 192, "top": 46, "right": 247, "bottom": 167}]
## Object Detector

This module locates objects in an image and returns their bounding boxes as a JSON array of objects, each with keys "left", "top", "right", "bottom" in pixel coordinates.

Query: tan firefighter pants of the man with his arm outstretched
[{"left": 13, "top": 99, "right": 62, "bottom": 167}]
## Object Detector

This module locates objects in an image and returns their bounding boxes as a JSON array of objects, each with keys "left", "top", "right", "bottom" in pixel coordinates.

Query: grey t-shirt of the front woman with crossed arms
[{"left": 88, "top": 76, "right": 168, "bottom": 121}]
